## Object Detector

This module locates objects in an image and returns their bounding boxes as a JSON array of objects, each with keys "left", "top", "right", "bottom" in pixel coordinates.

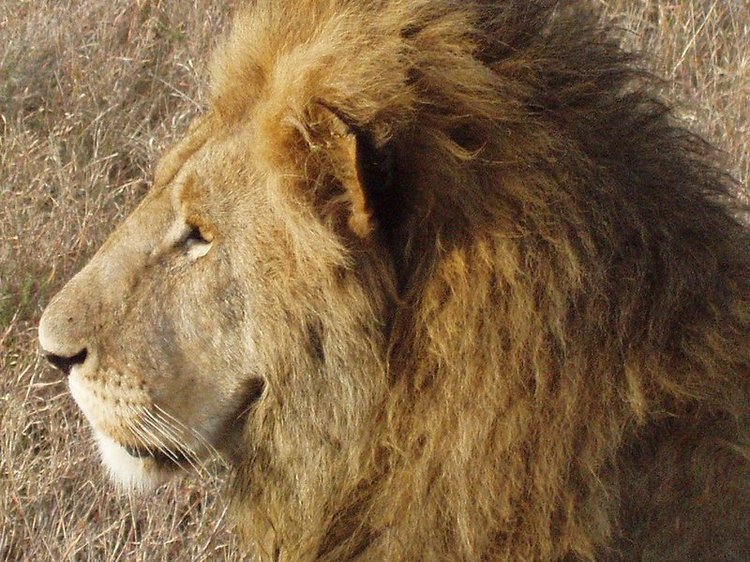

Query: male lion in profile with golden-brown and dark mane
[{"left": 39, "top": 0, "right": 750, "bottom": 562}]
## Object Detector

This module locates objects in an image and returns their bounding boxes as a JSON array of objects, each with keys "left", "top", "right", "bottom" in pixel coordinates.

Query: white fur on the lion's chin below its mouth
[{"left": 94, "top": 430, "right": 172, "bottom": 492}]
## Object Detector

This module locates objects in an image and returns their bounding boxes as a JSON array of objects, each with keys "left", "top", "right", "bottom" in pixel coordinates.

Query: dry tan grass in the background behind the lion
[{"left": 0, "top": 0, "right": 750, "bottom": 562}]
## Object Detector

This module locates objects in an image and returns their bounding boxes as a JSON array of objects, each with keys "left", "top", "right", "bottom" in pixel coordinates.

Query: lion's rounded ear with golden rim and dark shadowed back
[{"left": 320, "top": 105, "right": 394, "bottom": 238}]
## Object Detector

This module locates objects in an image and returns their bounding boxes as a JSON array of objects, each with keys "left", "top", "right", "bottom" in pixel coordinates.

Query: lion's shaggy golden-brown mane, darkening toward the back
[{"left": 213, "top": 0, "right": 750, "bottom": 560}]
